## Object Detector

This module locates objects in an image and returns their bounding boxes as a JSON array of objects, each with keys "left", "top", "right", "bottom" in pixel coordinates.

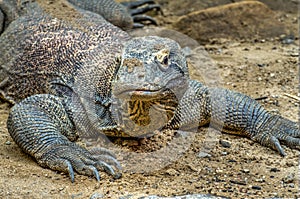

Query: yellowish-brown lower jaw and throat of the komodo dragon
[{"left": 112, "top": 89, "right": 179, "bottom": 137}]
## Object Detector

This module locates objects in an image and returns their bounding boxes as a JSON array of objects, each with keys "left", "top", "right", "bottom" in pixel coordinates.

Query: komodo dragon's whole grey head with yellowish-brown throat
[{"left": 112, "top": 36, "right": 189, "bottom": 137}]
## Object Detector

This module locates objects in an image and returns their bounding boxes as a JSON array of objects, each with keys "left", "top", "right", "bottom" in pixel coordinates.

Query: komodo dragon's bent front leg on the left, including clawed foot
[{"left": 7, "top": 94, "right": 120, "bottom": 182}]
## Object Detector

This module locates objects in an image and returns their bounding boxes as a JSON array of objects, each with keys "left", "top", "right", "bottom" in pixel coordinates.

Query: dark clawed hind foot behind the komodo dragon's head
[{"left": 121, "top": 0, "right": 161, "bottom": 28}]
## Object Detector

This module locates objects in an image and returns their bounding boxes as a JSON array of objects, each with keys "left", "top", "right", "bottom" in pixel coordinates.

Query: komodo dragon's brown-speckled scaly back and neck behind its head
[{"left": 0, "top": 0, "right": 129, "bottom": 103}]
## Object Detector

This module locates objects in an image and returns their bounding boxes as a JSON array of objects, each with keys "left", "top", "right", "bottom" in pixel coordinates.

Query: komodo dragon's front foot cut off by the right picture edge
[{"left": 253, "top": 115, "right": 300, "bottom": 156}]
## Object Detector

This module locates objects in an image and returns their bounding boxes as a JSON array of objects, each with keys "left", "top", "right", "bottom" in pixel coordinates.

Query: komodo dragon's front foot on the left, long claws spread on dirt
[{"left": 37, "top": 143, "right": 121, "bottom": 182}]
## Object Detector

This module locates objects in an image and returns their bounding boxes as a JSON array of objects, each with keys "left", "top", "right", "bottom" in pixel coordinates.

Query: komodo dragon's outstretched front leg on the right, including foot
[{"left": 167, "top": 80, "right": 300, "bottom": 156}]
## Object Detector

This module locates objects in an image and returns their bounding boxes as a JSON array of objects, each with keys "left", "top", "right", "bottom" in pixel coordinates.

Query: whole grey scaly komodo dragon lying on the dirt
[{"left": 0, "top": 0, "right": 300, "bottom": 185}]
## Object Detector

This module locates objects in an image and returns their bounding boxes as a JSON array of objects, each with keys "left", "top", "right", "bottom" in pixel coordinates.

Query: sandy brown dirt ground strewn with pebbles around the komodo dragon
[{"left": 0, "top": 0, "right": 300, "bottom": 199}]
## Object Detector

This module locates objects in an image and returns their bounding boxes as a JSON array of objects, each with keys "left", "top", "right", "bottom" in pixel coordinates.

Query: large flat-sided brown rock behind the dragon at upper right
[{"left": 173, "top": 1, "right": 287, "bottom": 43}]
